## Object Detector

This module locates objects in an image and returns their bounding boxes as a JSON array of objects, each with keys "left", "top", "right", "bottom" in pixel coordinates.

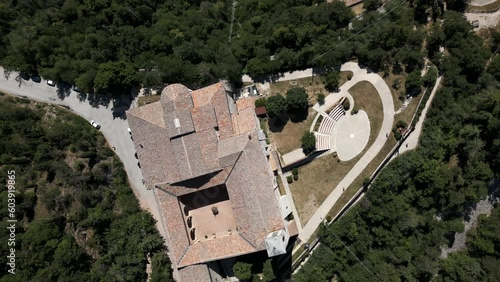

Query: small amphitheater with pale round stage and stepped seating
[{"left": 314, "top": 98, "right": 370, "bottom": 161}]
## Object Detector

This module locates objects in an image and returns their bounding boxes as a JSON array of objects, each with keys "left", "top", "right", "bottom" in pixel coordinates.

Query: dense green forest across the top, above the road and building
[{"left": 0, "top": 0, "right": 446, "bottom": 92}]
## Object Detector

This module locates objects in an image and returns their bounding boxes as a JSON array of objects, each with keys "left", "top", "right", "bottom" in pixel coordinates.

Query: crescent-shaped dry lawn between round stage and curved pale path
[{"left": 347, "top": 81, "right": 384, "bottom": 148}]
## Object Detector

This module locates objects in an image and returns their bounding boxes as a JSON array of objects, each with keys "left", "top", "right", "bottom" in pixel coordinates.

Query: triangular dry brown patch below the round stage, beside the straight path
[{"left": 290, "top": 154, "right": 361, "bottom": 225}]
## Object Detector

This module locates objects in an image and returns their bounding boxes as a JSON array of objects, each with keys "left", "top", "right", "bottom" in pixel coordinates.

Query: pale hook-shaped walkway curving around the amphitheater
[{"left": 299, "top": 62, "right": 394, "bottom": 242}]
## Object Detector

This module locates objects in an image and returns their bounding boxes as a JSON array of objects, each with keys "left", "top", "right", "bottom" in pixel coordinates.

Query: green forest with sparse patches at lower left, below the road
[{"left": 0, "top": 94, "right": 172, "bottom": 282}]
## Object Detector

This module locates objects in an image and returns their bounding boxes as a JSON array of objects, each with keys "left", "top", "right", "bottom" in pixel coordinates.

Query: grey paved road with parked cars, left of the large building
[{"left": 0, "top": 67, "right": 165, "bottom": 239}]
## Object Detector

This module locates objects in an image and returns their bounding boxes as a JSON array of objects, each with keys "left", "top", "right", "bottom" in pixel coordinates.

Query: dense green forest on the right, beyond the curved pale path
[{"left": 294, "top": 11, "right": 500, "bottom": 282}]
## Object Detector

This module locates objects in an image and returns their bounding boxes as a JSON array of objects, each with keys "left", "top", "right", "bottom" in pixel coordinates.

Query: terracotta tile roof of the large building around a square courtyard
[{"left": 127, "top": 83, "right": 284, "bottom": 270}]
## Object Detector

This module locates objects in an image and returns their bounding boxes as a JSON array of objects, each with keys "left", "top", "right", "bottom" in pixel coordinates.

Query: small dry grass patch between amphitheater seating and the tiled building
[{"left": 266, "top": 108, "right": 316, "bottom": 154}]
